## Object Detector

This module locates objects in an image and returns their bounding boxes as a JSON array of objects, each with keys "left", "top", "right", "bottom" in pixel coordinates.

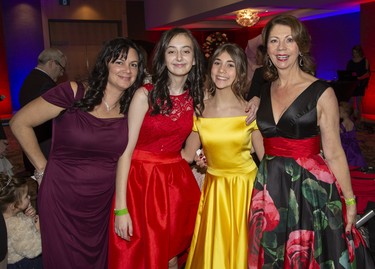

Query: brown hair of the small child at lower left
[{"left": 0, "top": 173, "right": 27, "bottom": 213}]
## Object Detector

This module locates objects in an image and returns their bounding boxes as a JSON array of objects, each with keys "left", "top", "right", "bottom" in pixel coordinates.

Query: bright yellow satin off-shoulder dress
[{"left": 185, "top": 116, "right": 258, "bottom": 269}]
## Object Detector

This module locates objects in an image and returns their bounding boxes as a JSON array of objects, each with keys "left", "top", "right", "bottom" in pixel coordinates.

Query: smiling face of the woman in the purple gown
[{"left": 108, "top": 48, "right": 139, "bottom": 90}]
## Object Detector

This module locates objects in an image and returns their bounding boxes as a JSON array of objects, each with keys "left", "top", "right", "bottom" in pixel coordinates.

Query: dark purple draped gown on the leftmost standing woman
[{"left": 38, "top": 82, "right": 128, "bottom": 269}]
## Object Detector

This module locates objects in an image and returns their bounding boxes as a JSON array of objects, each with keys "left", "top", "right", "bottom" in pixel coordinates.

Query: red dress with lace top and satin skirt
[{"left": 108, "top": 84, "right": 200, "bottom": 269}]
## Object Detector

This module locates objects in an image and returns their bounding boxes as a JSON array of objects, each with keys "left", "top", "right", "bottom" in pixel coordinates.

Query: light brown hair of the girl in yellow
[{"left": 208, "top": 43, "right": 248, "bottom": 100}]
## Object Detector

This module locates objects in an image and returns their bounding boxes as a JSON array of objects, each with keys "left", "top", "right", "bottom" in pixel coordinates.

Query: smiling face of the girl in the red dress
[{"left": 165, "top": 34, "right": 195, "bottom": 76}]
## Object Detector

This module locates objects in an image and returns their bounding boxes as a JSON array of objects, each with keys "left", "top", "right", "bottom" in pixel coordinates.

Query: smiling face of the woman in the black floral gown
[{"left": 267, "top": 24, "right": 299, "bottom": 69}]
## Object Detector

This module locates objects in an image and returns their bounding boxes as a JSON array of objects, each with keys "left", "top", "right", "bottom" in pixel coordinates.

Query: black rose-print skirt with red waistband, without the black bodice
[{"left": 248, "top": 138, "right": 351, "bottom": 269}]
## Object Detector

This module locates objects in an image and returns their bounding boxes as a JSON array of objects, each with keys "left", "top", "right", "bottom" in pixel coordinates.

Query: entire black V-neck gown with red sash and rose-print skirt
[{"left": 248, "top": 80, "right": 354, "bottom": 269}]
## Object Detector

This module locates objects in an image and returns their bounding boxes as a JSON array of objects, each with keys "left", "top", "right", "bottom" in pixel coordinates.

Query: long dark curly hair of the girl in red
[{"left": 149, "top": 28, "right": 205, "bottom": 115}]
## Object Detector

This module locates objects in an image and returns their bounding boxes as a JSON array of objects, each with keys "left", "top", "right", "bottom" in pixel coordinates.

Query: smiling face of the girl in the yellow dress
[{"left": 211, "top": 51, "right": 237, "bottom": 89}]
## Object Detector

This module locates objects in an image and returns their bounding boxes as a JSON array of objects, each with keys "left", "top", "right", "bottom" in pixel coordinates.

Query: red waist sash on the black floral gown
[{"left": 263, "top": 136, "right": 320, "bottom": 159}]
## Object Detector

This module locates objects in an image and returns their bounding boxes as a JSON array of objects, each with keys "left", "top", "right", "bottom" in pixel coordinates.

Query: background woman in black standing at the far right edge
[{"left": 346, "top": 45, "right": 370, "bottom": 127}]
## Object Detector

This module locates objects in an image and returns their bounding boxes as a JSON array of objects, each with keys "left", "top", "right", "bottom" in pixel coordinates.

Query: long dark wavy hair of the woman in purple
[{"left": 75, "top": 37, "right": 145, "bottom": 114}]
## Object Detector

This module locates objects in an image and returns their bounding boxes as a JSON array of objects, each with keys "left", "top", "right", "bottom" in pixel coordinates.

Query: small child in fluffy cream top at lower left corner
[{"left": 0, "top": 174, "right": 43, "bottom": 269}]
